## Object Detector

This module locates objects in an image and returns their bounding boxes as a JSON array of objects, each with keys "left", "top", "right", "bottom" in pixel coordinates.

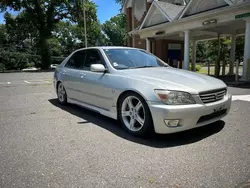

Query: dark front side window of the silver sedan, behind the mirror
[{"left": 83, "top": 49, "right": 105, "bottom": 70}]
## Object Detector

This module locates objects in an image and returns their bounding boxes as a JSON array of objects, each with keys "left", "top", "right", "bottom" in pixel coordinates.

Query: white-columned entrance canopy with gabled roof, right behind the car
[{"left": 135, "top": 0, "right": 250, "bottom": 81}]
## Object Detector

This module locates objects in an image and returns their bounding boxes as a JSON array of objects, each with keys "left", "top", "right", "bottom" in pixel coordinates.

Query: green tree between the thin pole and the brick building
[{"left": 102, "top": 14, "right": 127, "bottom": 46}]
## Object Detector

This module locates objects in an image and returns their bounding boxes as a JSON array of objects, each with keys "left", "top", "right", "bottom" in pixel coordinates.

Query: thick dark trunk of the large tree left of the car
[{"left": 39, "top": 32, "right": 51, "bottom": 69}]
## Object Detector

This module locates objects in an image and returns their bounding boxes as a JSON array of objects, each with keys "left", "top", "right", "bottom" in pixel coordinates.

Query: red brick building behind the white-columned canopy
[{"left": 123, "top": 0, "right": 186, "bottom": 67}]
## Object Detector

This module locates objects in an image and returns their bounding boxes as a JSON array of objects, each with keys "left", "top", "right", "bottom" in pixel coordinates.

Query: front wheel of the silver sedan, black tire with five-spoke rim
[{"left": 118, "top": 92, "right": 154, "bottom": 137}]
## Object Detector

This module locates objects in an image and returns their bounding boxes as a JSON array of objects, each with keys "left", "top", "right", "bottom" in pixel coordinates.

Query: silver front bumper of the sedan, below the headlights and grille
[{"left": 148, "top": 94, "right": 232, "bottom": 134}]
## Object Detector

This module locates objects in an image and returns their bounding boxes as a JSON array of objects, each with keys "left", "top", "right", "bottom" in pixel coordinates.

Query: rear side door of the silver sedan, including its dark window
[{"left": 62, "top": 50, "right": 86, "bottom": 100}]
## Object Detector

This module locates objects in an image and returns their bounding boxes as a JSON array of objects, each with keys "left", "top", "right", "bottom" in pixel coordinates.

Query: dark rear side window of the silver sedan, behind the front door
[{"left": 65, "top": 50, "right": 86, "bottom": 69}]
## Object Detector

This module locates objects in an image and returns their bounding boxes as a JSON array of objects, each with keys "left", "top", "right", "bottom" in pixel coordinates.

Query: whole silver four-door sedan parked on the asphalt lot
[{"left": 54, "top": 47, "right": 232, "bottom": 136}]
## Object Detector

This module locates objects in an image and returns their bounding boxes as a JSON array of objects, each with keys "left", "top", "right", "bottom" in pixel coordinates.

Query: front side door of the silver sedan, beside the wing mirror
[{"left": 77, "top": 49, "right": 113, "bottom": 110}]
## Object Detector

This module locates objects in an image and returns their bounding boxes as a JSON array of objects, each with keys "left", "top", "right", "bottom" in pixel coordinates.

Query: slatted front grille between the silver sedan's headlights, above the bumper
[{"left": 200, "top": 88, "right": 227, "bottom": 104}]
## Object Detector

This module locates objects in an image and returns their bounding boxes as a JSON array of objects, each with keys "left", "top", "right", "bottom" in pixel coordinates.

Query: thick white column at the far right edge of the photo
[{"left": 243, "top": 19, "right": 250, "bottom": 81}]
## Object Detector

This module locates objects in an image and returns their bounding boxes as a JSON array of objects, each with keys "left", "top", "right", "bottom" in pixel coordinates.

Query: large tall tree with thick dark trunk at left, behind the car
[{"left": 0, "top": 0, "right": 73, "bottom": 69}]
